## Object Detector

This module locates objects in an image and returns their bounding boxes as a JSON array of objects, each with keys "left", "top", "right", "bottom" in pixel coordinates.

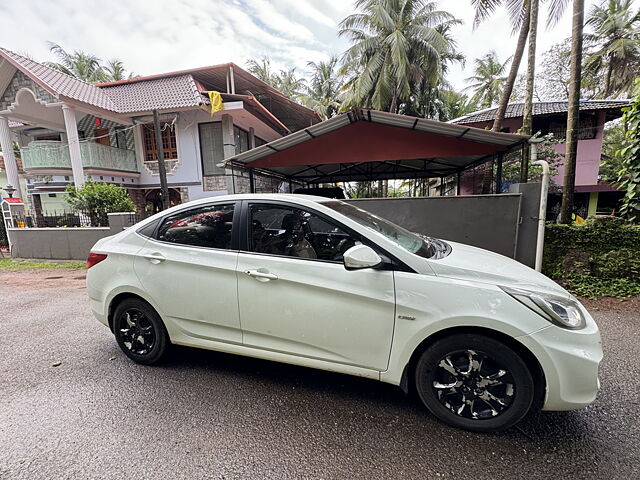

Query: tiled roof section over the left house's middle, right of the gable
[{"left": 100, "top": 75, "right": 202, "bottom": 113}]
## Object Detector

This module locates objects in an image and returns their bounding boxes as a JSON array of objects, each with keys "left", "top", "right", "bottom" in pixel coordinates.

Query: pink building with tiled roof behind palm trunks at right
[{"left": 452, "top": 100, "right": 628, "bottom": 215}]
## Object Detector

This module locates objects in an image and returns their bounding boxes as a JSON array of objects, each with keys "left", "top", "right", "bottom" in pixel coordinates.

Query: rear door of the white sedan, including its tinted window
[{"left": 134, "top": 202, "right": 242, "bottom": 344}]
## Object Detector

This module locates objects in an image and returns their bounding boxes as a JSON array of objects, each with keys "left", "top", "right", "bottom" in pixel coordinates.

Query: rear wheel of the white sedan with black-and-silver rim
[{"left": 113, "top": 298, "right": 170, "bottom": 365}]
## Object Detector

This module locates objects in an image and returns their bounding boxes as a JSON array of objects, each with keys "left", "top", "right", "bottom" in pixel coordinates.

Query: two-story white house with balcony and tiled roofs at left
[{"left": 0, "top": 48, "right": 319, "bottom": 211}]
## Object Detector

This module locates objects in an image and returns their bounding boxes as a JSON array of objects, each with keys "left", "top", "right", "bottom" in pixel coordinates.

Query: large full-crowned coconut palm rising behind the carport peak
[{"left": 339, "top": 0, "right": 460, "bottom": 112}]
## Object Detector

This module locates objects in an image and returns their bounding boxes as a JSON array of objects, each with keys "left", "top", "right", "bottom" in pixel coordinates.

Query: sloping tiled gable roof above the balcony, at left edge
[{"left": 0, "top": 48, "right": 116, "bottom": 111}]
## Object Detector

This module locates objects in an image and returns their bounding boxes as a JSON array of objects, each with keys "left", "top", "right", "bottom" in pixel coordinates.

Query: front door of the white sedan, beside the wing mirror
[{"left": 238, "top": 202, "right": 395, "bottom": 371}]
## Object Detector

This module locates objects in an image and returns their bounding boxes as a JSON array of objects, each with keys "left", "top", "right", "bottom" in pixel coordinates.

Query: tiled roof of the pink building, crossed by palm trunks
[{"left": 450, "top": 100, "right": 629, "bottom": 124}]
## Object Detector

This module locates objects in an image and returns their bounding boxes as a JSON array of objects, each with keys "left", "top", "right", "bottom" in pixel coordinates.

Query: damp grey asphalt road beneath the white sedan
[{"left": 0, "top": 271, "right": 640, "bottom": 480}]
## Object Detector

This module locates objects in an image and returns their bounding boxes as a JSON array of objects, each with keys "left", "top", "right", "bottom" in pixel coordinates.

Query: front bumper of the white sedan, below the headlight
[{"left": 518, "top": 318, "right": 602, "bottom": 410}]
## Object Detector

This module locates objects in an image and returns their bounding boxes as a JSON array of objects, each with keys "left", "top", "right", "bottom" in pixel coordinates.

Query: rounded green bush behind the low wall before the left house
[{"left": 65, "top": 181, "right": 136, "bottom": 226}]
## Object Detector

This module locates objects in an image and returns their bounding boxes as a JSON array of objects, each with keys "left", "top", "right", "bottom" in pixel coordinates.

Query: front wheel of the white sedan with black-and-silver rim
[{"left": 415, "top": 334, "right": 534, "bottom": 432}]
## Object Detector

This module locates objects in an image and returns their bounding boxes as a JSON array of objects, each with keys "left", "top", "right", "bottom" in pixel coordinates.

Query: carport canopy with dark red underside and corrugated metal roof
[{"left": 225, "top": 109, "right": 529, "bottom": 183}]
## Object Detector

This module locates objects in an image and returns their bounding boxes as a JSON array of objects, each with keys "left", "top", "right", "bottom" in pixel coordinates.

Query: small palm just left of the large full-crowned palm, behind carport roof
[{"left": 302, "top": 56, "right": 344, "bottom": 120}]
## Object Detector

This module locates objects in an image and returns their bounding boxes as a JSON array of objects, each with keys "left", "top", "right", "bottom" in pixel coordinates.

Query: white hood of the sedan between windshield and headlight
[{"left": 429, "top": 241, "right": 570, "bottom": 296}]
